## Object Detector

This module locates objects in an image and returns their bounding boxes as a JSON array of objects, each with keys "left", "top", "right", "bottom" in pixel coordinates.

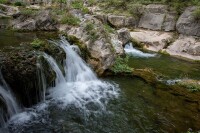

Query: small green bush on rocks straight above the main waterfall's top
[{"left": 60, "top": 13, "right": 80, "bottom": 26}]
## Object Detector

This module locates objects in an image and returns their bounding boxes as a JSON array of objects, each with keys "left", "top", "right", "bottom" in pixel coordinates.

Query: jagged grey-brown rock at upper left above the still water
[{"left": 12, "top": 10, "right": 57, "bottom": 31}]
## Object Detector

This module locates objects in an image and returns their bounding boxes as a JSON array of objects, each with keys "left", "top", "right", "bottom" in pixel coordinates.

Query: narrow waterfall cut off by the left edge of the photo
[{"left": 0, "top": 73, "right": 19, "bottom": 127}]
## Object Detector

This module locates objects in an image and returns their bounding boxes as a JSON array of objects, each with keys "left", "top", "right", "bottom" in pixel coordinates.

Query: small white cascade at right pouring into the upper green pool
[{"left": 124, "top": 43, "right": 156, "bottom": 58}]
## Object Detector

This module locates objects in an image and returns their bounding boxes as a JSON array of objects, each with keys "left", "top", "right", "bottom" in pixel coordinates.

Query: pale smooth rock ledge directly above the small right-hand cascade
[{"left": 131, "top": 30, "right": 173, "bottom": 52}]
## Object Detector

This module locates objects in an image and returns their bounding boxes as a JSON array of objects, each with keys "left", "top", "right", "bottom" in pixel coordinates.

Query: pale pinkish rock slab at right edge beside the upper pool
[{"left": 166, "top": 35, "right": 200, "bottom": 60}]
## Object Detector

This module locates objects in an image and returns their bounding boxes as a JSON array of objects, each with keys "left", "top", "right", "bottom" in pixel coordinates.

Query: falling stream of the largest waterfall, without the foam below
[{"left": 52, "top": 37, "right": 97, "bottom": 82}]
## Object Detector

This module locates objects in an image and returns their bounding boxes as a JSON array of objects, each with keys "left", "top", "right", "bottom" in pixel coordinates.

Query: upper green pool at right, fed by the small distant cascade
[{"left": 129, "top": 54, "right": 200, "bottom": 80}]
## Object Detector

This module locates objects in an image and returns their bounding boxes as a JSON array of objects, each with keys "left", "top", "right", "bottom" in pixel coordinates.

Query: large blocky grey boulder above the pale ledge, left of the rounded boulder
[{"left": 138, "top": 4, "right": 176, "bottom": 31}]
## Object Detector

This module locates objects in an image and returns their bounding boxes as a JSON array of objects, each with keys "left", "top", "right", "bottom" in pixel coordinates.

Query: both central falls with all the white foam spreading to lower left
[{"left": 5, "top": 37, "right": 118, "bottom": 132}]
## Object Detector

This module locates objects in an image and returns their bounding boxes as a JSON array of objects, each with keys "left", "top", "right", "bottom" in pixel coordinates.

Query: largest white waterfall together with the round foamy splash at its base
[{"left": 48, "top": 37, "right": 118, "bottom": 110}]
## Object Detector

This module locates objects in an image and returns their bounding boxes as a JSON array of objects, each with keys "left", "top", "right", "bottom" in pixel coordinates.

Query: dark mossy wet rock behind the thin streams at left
[{"left": 0, "top": 44, "right": 65, "bottom": 107}]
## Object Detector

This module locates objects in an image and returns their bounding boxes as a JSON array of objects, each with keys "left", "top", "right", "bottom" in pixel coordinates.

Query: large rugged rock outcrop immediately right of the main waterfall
[{"left": 66, "top": 15, "right": 124, "bottom": 75}]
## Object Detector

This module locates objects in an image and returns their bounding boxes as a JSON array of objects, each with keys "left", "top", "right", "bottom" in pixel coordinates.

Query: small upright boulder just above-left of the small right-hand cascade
[{"left": 117, "top": 28, "right": 131, "bottom": 45}]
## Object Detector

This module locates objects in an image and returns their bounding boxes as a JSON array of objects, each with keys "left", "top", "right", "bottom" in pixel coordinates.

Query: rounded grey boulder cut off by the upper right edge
[{"left": 176, "top": 6, "right": 200, "bottom": 36}]
